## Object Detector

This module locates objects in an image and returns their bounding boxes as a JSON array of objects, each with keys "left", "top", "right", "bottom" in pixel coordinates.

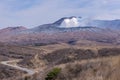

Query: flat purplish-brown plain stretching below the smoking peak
[{"left": 0, "top": 26, "right": 120, "bottom": 46}]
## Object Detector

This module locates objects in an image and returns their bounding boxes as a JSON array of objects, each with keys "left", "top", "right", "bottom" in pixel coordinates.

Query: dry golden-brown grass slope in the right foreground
[{"left": 56, "top": 56, "right": 120, "bottom": 80}]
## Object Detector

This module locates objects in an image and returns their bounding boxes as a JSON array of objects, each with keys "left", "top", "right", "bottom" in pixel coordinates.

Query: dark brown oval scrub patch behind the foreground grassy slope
[{"left": 44, "top": 48, "right": 96, "bottom": 65}]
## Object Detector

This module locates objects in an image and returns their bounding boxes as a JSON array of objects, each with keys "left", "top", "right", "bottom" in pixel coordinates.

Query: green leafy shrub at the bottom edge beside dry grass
[{"left": 45, "top": 68, "right": 61, "bottom": 80}]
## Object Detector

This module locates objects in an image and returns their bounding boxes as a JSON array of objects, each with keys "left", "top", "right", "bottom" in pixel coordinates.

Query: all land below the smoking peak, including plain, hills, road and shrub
[{"left": 0, "top": 21, "right": 120, "bottom": 80}]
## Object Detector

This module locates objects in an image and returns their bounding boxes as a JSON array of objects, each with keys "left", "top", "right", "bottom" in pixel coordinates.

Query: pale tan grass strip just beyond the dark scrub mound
[{"left": 30, "top": 40, "right": 120, "bottom": 53}]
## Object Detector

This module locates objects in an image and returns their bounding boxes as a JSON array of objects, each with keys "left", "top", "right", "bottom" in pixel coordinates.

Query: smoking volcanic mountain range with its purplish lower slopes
[{"left": 0, "top": 16, "right": 120, "bottom": 45}]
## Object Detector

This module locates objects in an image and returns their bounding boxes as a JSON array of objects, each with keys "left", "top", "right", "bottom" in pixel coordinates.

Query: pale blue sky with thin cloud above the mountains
[{"left": 0, "top": 0, "right": 120, "bottom": 28}]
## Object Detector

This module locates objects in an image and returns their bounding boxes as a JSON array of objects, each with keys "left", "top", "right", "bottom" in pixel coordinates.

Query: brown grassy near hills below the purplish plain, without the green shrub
[{"left": 0, "top": 40, "right": 120, "bottom": 80}]
